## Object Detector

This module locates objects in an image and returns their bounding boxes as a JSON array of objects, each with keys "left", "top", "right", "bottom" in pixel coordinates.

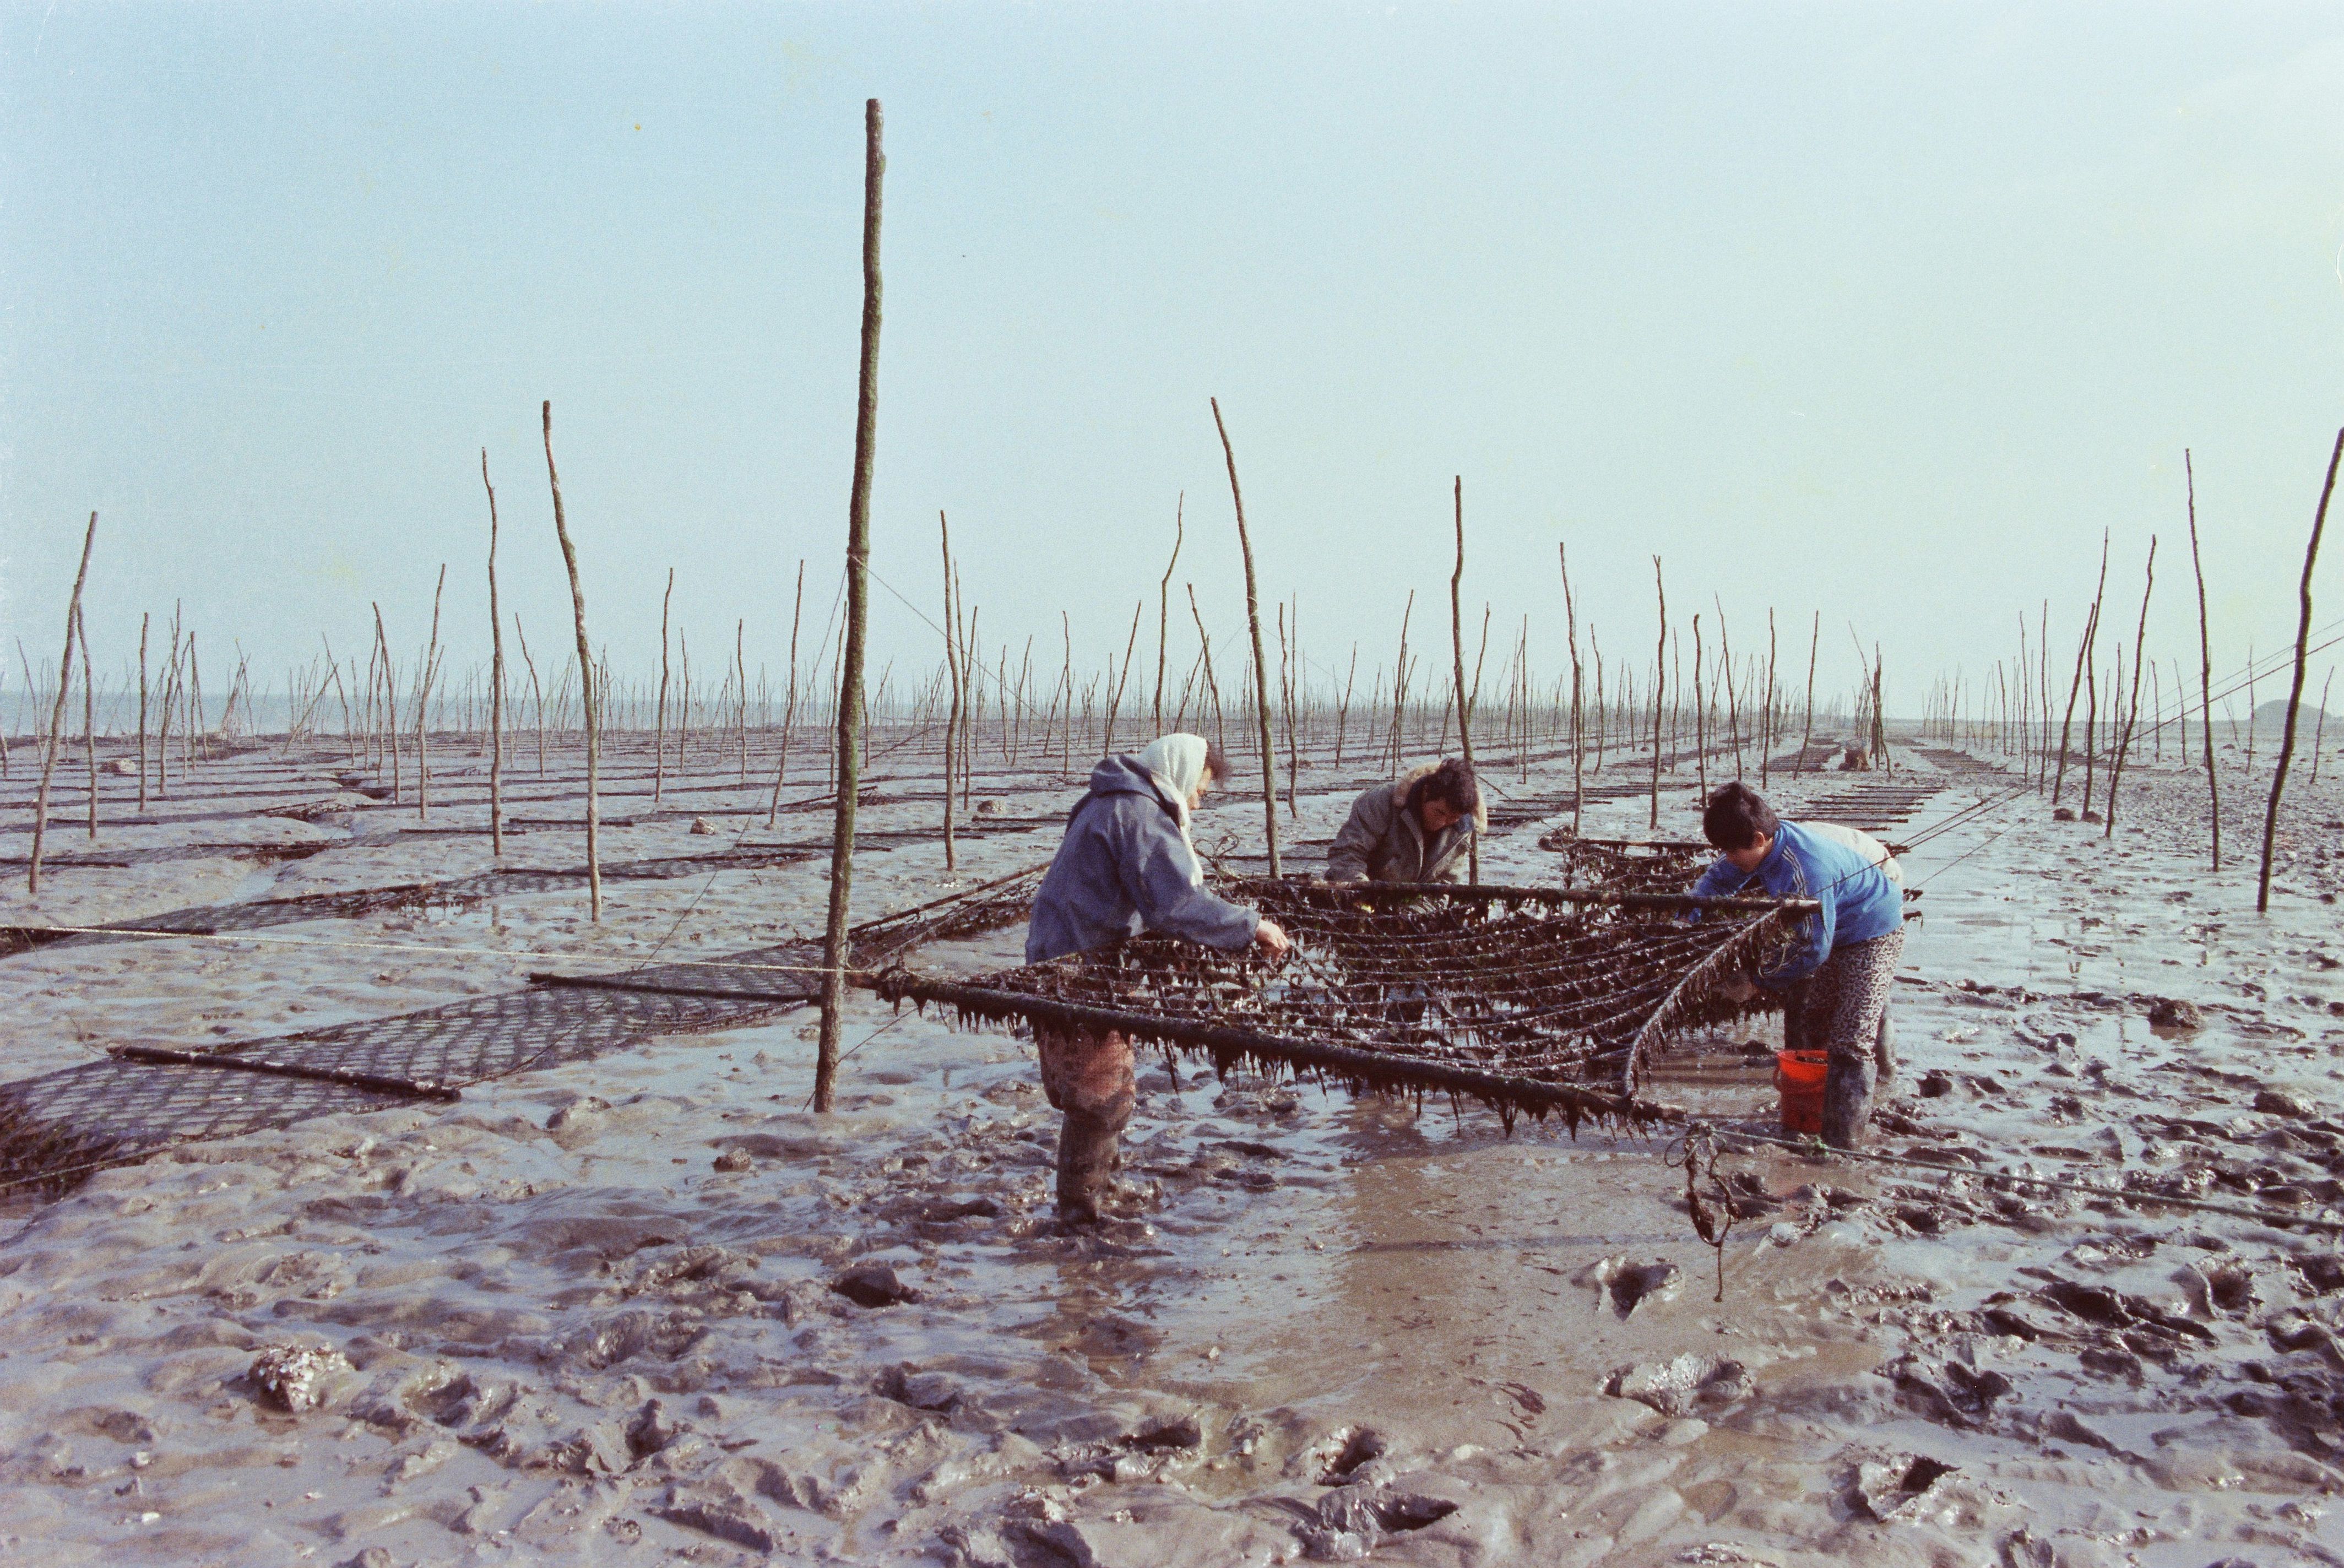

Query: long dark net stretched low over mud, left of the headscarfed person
[{"left": 0, "top": 867, "right": 1041, "bottom": 1191}]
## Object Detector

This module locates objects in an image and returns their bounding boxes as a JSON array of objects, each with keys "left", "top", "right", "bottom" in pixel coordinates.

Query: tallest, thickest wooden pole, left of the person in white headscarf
[{"left": 813, "top": 99, "right": 886, "bottom": 1111}]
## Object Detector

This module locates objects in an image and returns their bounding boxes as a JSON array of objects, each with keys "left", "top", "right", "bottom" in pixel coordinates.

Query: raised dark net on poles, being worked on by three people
[{"left": 877, "top": 879, "right": 1814, "bottom": 1125}]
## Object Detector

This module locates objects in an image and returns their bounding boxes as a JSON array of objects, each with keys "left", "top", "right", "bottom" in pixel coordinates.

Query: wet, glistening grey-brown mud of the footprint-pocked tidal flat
[{"left": 0, "top": 740, "right": 2344, "bottom": 1568}]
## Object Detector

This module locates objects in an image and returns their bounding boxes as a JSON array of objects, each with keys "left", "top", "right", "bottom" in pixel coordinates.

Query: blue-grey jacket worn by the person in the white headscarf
[{"left": 1027, "top": 757, "right": 1261, "bottom": 963}]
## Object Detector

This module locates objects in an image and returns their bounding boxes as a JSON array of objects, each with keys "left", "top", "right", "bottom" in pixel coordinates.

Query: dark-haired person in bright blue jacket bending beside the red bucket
[{"left": 1692, "top": 780, "right": 1903, "bottom": 1148}]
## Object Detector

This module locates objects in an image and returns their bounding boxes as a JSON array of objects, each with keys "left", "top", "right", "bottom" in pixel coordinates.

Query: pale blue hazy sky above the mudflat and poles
[{"left": 0, "top": 0, "right": 2344, "bottom": 708}]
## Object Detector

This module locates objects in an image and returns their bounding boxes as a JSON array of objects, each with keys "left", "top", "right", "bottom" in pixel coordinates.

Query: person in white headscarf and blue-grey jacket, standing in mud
[{"left": 1027, "top": 734, "right": 1289, "bottom": 1223}]
